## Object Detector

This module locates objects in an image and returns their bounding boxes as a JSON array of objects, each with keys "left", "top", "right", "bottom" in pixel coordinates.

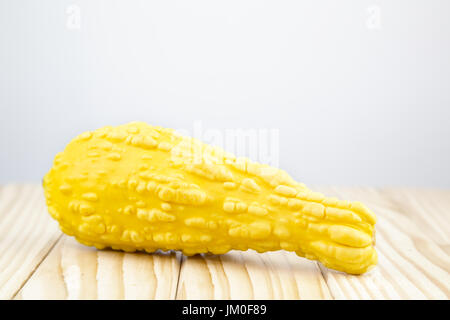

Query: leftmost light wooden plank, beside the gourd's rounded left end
[{"left": 0, "top": 184, "right": 61, "bottom": 299}]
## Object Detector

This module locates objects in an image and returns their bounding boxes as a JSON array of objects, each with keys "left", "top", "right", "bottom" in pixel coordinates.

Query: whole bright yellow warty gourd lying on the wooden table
[{"left": 44, "top": 122, "right": 377, "bottom": 274}]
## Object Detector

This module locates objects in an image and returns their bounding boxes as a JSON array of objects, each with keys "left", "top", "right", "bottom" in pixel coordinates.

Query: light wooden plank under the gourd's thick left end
[{"left": 17, "top": 236, "right": 180, "bottom": 299}]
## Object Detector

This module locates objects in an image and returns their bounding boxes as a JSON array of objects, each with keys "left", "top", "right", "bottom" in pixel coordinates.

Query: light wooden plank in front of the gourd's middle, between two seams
[{"left": 177, "top": 250, "right": 331, "bottom": 300}]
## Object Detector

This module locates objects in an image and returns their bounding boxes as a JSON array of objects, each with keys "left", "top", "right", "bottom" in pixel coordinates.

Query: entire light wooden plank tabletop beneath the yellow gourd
[{"left": 0, "top": 184, "right": 450, "bottom": 299}]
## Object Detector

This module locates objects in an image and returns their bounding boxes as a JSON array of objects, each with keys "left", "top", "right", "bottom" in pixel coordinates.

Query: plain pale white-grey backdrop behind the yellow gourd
[{"left": 0, "top": 0, "right": 450, "bottom": 188}]
